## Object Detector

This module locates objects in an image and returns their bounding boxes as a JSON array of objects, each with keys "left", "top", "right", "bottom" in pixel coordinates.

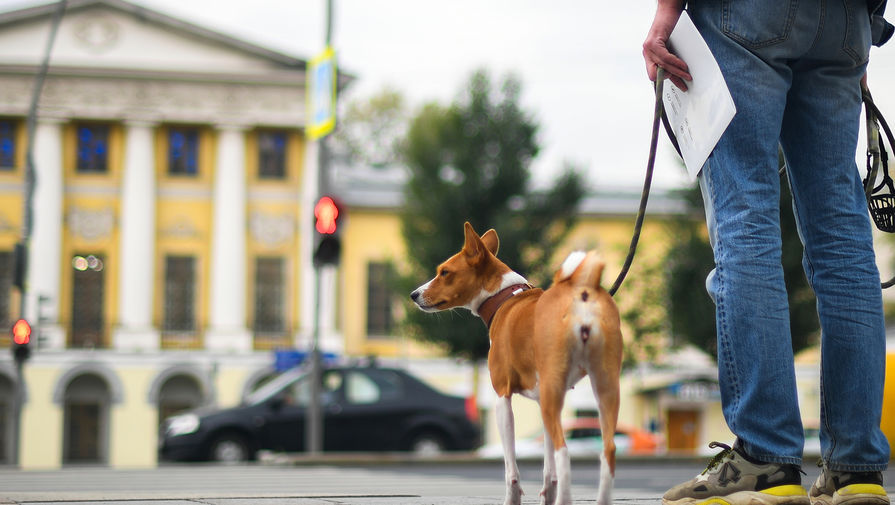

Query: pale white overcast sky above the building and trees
[{"left": 0, "top": 0, "right": 895, "bottom": 189}]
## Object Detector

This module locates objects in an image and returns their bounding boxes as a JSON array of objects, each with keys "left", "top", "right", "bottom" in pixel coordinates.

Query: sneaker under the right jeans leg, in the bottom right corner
[{"left": 808, "top": 465, "right": 889, "bottom": 505}]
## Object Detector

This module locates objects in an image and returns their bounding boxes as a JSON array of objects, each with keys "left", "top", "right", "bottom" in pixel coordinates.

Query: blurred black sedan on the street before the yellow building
[{"left": 159, "top": 367, "right": 481, "bottom": 461}]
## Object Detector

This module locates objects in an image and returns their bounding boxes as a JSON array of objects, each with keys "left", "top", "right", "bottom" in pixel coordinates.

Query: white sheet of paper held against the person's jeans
[{"left": 662, "top": 11, "right": 736, "bottom": 181}]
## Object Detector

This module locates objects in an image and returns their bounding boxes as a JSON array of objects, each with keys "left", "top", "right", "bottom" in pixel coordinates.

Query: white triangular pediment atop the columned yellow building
[{"left": 0, "top": 0, "right": 305, "bottom": 75}]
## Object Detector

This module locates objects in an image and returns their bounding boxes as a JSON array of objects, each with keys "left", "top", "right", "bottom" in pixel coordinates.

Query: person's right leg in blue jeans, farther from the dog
[{"left": 781, "top": 2, "right": 889, "bottom": 472}]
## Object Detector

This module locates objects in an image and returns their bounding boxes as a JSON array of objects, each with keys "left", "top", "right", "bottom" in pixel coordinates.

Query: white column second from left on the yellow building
[{"left": 113, "top": 121, "right": 159, "bottom": 351}]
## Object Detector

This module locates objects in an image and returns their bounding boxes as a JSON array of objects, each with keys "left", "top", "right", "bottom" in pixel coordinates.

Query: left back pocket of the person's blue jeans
[{"left": 721, "top": 0, "right": 799, "bottom": 49}]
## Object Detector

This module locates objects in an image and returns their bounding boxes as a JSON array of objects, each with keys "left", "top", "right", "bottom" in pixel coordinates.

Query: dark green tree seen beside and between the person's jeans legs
[{"left": 666, "top": 174, "right": 820, "bottom": 357}]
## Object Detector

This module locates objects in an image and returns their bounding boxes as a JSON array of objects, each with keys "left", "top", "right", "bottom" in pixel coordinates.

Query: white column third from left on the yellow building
[{"left": 205, "top": 126, "right": 252, "bottom": 352}]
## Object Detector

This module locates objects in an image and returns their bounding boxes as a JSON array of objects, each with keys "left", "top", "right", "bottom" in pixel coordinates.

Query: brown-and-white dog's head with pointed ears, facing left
[{"left": 410, "top": 222, "right": 502, "bottom": 312}]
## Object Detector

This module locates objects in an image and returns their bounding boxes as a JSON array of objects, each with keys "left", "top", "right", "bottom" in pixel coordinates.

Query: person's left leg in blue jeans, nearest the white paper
[{"left": 690, "top": 0, "right": 812, "bottom": 465}]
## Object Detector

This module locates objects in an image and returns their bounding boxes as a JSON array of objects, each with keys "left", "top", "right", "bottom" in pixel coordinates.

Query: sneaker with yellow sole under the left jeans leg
[{"left": 662, "top": 442, "right": 810, "bottom": 505}]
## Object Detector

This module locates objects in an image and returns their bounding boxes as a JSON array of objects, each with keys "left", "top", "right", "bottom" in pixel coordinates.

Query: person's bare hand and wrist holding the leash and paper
[{"left": 643, "top": 0, "right": 693, "bottom": 91}]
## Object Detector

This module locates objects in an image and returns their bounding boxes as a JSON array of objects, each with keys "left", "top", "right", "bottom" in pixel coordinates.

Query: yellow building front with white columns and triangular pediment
[{"left": 0, "top": 0, "right": 326, "bottom": 468}]
